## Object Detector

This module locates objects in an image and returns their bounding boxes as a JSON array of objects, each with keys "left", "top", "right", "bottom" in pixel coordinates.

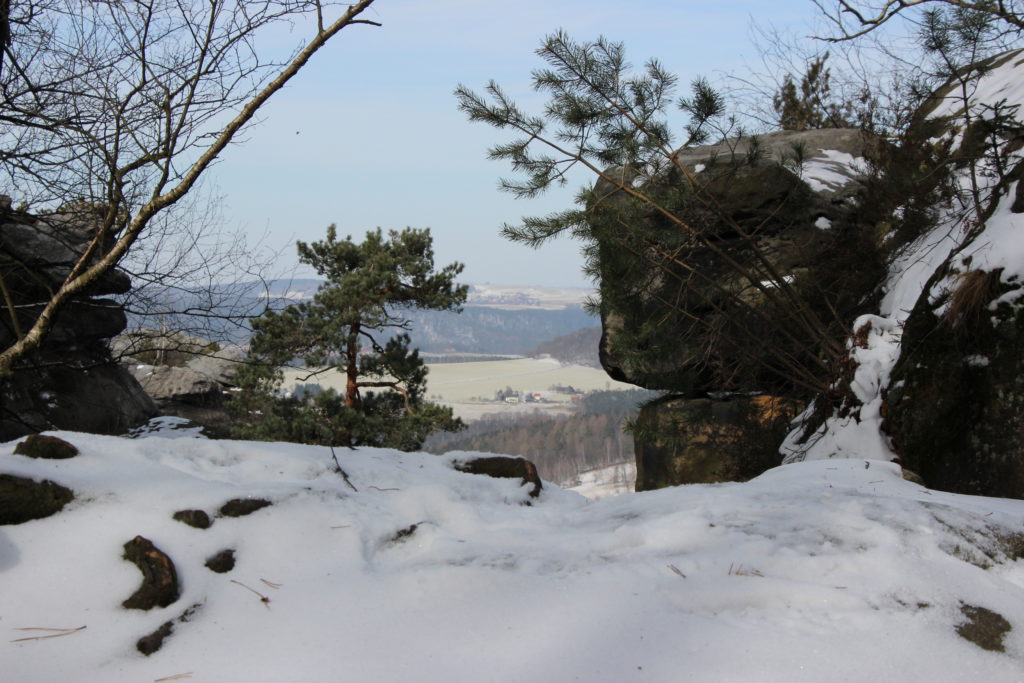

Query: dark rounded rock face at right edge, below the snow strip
[{"left": 886, "top": 272, "right": 1024, "bottom": 498}]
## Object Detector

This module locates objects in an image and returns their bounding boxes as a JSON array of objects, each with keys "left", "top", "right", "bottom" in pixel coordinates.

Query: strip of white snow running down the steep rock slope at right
[{"left": 780, "top": 52, "right": 1024, "bottom": 471}]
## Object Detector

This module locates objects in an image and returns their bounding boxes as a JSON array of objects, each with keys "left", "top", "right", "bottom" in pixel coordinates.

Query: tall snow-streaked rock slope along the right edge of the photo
[{"left": 783, "top": 50, "right": 1024, "bottom": 498}]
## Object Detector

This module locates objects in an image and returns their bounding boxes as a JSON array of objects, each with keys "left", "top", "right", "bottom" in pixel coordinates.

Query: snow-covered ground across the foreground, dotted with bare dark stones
[{"left": 0, "top": 432, "right": 1024, "bottom": 683}]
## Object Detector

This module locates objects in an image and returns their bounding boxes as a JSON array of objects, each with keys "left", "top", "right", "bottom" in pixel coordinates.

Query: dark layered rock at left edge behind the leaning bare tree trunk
[{"left": 0, "top": 209, "right": 156, "bottom": 441}]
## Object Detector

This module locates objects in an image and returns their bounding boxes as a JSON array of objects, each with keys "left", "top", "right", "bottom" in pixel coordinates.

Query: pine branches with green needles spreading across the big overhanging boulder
[{"left": 456, "top": 32, "right": 851, "bottom": 393}]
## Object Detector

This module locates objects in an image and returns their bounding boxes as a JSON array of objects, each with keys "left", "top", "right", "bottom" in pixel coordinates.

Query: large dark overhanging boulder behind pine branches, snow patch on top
[{"left": 595, "top": 129, "right": 881, "bottom": 396}]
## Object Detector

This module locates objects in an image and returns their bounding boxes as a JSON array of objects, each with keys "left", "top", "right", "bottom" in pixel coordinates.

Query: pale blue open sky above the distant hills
[{"left": 210, "top": 0, "right": 817, "bottom": 287}]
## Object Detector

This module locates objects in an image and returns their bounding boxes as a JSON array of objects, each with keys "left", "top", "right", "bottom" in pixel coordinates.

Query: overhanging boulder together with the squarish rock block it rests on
[{"left": 595, "top": 129, "right": 883, "bottom": 490}]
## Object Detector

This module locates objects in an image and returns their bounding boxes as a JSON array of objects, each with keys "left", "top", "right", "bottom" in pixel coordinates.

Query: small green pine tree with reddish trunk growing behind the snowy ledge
[{"left": 231, "top": 225, "right": 468, "bottom": 451}]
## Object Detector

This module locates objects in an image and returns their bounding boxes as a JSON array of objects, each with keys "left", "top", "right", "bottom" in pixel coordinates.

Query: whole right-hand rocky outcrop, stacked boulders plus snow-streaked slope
[{"left": 602, "top": 50, "right": 1024, "bottom": 498}]
